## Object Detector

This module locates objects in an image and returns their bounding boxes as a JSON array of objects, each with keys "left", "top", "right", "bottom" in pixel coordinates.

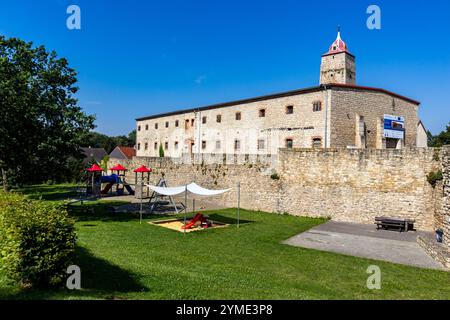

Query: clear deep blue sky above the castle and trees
[{"left": 0, "top": 0, "right": 450, "bottom": 135}]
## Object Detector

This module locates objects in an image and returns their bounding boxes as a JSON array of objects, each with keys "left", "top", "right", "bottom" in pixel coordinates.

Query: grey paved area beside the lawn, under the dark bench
[{"left": 284, "top": 221, "right": 443, "bottom": 270}]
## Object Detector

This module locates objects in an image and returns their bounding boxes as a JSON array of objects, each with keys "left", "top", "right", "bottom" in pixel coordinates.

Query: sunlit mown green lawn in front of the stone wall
[{"left": 0, "top": 186, "right": 450, "bottom": 299}]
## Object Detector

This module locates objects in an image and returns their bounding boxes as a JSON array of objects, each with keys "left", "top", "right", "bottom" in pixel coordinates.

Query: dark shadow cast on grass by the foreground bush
[{"left": 0, "top": 247, "right": 148, "bottom": 300}]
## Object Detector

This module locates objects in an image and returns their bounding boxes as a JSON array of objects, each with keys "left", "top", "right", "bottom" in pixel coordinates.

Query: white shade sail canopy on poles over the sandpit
[{"left": 146, "top": 182, "right": 240, "bottom": 232}]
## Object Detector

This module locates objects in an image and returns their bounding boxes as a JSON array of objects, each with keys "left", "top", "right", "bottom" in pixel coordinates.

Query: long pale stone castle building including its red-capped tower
[{"left": 136, "top": 32, "right": 427, "bottom": 157}]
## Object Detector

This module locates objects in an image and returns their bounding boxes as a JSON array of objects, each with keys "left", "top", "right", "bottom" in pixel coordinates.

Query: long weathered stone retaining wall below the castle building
[{"left": 111, "top": 148, "right": 440, "bottom": 234}]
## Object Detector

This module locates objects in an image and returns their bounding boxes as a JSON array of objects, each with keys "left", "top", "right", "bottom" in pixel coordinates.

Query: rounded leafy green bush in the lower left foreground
[{"left": 0, "top": 192, "right": 76, "bottom": 287}]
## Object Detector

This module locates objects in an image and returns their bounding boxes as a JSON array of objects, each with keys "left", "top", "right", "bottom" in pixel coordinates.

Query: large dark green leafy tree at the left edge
[{"left": 0, "top": 36, "right": 95, "bottom": 190}]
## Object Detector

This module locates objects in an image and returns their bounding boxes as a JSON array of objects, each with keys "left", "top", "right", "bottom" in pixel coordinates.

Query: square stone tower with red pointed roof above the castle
[{"left": 320, "top": 30, "right": 356, "bottom": 85}]
